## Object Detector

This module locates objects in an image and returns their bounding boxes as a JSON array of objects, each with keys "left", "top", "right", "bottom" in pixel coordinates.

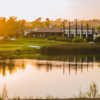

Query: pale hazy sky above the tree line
[{"left": 0, "top": 0, "right": 100, "bottom": 21}]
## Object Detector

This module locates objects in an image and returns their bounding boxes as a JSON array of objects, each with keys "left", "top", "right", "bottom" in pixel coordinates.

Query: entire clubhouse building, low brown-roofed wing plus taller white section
[{"left": 24, "top": 22, "right": 100, "bottom": 41}]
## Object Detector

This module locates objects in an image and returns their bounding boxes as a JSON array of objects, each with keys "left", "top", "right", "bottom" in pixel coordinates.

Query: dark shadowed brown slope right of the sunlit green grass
[{"left": 41, "top": 43, "right": 100, "bottom": 55}]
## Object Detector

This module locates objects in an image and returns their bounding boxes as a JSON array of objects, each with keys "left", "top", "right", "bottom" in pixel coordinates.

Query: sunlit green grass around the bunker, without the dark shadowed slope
[{"left": 0, "top": 38, "right": 66, "bottom": 59}]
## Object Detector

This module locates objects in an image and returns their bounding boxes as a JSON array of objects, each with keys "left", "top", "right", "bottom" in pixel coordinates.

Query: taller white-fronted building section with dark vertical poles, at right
[{"left": 65, "top": 23, "right": 95, "bottom": 40}]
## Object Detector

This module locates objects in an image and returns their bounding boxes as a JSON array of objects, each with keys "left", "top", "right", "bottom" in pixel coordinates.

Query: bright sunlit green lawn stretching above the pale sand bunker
[{"left": 0, "top": 38, "right": 69, "bottom": 51}]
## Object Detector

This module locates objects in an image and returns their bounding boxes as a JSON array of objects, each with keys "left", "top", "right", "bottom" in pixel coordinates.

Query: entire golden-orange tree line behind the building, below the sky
[{"left": 0, "top": 16, "right": 100, "bottom": 38}]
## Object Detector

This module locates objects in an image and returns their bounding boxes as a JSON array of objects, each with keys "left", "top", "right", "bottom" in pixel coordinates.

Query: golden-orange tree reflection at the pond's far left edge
[{"left": 0, "top": 59, "right": 26, "bottom": 76}]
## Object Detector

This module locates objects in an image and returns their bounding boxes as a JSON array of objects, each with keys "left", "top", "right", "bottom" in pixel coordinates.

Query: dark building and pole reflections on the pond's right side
[{"left": 36, "top": 56, "right": 96, "bottom": 74}]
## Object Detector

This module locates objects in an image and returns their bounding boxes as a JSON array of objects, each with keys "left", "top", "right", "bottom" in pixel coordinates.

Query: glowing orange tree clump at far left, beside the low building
[{"left": 0, "top": 17, "right": 25, "bottom": 38}]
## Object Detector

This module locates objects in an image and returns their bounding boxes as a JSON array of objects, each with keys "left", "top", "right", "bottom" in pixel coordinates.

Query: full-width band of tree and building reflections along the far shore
[{"left": 0, "top": 56, "right": 99, "bottom": 76}]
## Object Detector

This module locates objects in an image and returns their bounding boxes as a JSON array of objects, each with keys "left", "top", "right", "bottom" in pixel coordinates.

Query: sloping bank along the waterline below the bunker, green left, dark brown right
[{"left": 0, "top": 43, "right": 100, "bottom": 59}]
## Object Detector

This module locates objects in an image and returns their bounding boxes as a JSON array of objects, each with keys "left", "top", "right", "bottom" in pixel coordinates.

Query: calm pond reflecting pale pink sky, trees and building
[{"left": 0, "top": 56, "right": 100, "bottom": 98}]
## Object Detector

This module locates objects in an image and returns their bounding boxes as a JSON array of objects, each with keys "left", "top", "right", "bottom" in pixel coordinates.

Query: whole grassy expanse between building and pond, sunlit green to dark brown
[{"left": 0, "top": 38, "right": 100, "bottom": 59}]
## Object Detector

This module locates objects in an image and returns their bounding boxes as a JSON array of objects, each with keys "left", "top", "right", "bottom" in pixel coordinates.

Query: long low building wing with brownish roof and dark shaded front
[{"left": 24, "top": 27, "right": 64, "bottom": 38}]
